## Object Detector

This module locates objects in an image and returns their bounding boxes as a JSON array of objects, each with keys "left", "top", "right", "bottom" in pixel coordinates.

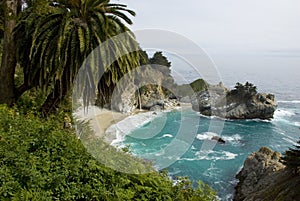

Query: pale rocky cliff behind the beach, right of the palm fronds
[{"left": 110, "top": 67, "right": 179, "bottom": 113}]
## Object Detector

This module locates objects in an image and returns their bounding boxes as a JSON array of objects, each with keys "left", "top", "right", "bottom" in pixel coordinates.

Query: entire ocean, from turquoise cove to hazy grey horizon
[{"left": 122, "top": 53, "right": 300, "bottom": 201}]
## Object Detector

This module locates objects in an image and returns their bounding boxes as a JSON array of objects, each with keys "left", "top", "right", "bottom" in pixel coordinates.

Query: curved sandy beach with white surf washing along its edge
[{"left": 73, "top": 103, "right": 191, "bottom": 146}]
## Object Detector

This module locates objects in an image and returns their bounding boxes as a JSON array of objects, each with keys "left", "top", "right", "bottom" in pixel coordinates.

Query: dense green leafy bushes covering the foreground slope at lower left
[{"left": 0, "top": 105, "right": 215, "bottom": 200}]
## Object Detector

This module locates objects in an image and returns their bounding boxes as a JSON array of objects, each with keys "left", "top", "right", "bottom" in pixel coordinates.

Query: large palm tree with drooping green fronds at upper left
[{"left": 16, "top": 0, "right": 139, "bottom": 113}]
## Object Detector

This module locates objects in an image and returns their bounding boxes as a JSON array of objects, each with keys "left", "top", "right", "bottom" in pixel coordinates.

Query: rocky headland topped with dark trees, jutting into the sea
[{"left": 191, "top": 83, "right": 277, "bottom": 119}]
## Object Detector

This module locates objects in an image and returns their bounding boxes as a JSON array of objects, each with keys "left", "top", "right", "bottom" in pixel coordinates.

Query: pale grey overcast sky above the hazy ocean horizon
[{"left": 119, "top": 0, "right": 300, "bottom": 52}]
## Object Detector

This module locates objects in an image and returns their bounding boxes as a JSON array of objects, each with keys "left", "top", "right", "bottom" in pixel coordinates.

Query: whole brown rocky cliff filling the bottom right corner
[{"left": 234, "top": 147, "right": 300, "bottom": 201}]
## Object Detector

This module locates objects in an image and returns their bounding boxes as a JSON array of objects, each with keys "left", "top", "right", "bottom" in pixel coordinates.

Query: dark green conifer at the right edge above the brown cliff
[{"left": 281, "top": 140, "right": 300, "bottom": 173}]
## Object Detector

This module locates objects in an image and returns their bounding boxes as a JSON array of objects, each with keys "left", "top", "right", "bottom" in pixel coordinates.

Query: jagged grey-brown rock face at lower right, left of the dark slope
[{"left": 234, "top": 147, "right": 285, "bottom": 201}]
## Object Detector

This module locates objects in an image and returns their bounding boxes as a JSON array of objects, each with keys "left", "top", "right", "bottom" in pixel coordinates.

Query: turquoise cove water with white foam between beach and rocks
[{"left": 123, "top": 101, "right": 300, "bottom": 200}]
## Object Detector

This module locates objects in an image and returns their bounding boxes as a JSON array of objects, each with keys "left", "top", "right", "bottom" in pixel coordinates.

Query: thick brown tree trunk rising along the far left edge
[{"left": 0, "top": 0, "right": 18, "bottom": 105}]
